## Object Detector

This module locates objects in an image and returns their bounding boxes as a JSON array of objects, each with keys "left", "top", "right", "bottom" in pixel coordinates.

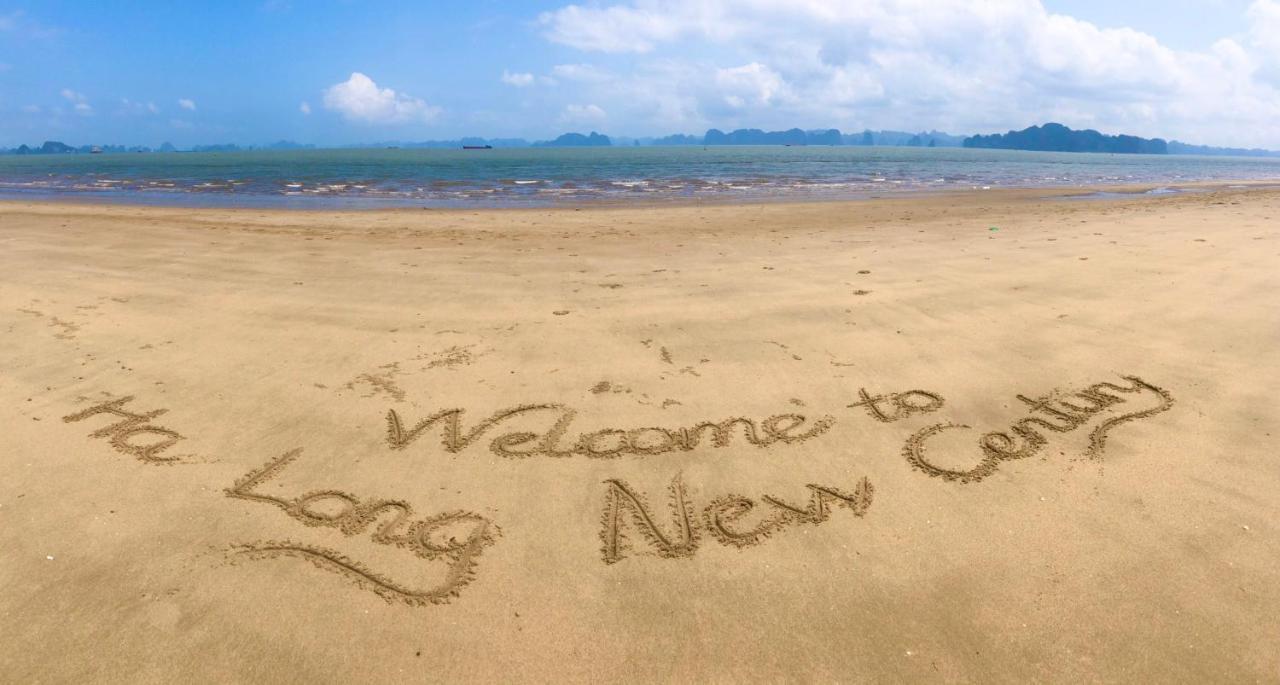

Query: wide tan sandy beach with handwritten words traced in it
[{"left": 0, "top": 188, "right": 1280, "bottom": 682}]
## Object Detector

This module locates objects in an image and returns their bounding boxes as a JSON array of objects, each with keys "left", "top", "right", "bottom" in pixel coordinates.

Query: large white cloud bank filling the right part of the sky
[{"left": 539, "top": 0, "right": 1280, "bottom": 146}]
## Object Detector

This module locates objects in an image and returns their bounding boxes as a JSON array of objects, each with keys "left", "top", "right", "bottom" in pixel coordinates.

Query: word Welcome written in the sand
[{"left": 387, "top": 405, "right": 835, "bottom": 457}]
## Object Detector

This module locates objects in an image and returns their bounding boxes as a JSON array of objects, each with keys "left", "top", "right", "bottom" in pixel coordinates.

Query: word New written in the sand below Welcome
[{"left": 600, "top": 474, "right": 876, "bottom": 563}]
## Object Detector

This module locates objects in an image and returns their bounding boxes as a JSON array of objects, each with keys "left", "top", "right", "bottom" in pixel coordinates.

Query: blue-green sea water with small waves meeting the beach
[{"left": 0, "top": 146, "right": 1280, "bottom": 209}]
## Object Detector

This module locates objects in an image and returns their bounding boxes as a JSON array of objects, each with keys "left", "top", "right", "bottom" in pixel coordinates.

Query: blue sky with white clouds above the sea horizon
[{"left": 0, "top": 0, "right": 1280, "bottom": 150}]
